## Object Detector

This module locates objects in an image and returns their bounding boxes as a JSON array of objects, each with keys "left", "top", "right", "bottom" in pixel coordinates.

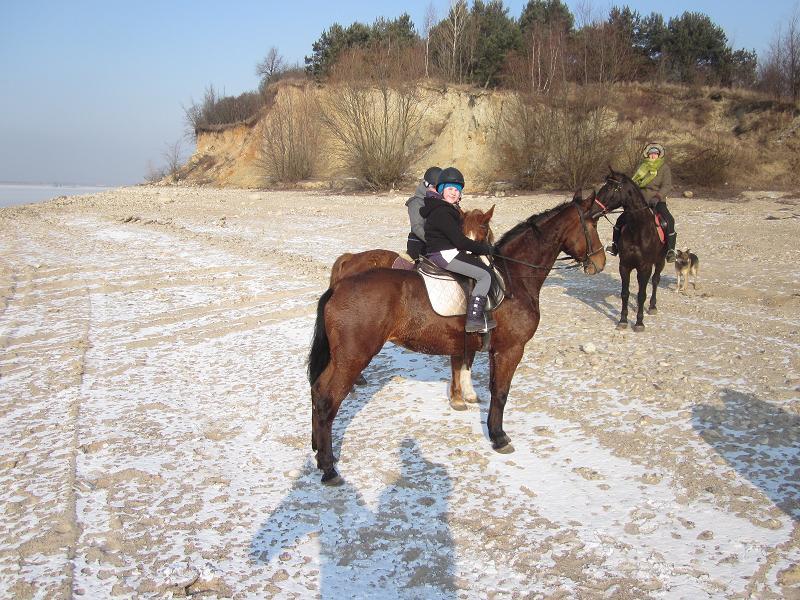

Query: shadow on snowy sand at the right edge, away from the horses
[{"left": 692, "top": 389, "right": 800, "bottom": 521}]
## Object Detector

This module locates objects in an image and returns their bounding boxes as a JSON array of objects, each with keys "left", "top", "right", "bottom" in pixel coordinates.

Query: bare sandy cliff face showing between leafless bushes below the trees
[{"left": 180, "top": 82, "right": 800, "bottom": 191}]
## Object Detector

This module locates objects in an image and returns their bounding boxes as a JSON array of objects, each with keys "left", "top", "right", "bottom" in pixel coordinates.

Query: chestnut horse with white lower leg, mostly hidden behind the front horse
[{"left": 328, "top": 206, "right": 494, "bottom": 410}]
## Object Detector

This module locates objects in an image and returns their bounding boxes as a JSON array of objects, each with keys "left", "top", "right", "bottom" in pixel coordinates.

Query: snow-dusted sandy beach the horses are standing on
[{"left": 0, "top": 187, "right": 800, "bottom": 599}]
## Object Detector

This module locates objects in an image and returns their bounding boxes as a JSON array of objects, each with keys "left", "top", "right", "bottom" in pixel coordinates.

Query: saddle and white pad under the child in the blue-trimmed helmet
[{"left": 417, "top": 257, "right": 505, "bottom": 317}]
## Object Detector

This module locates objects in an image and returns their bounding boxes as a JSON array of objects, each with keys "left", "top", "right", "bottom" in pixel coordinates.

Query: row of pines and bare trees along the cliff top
[{"left": 185, "top": 0, "right": 800, "bottom": 131}]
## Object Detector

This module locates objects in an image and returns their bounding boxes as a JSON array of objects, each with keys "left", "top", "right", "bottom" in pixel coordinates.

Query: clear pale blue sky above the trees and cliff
[{"left": 0, "top": 0, "right": 798, "bottom": 186}]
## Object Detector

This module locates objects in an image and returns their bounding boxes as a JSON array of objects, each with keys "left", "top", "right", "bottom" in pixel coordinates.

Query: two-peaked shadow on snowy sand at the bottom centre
[{"left": 250, "top": 437, "right": 457, "bottom": 599}]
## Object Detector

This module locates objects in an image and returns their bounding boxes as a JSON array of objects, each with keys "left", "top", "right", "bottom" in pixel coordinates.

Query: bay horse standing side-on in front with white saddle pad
[{"left": 308, "top": 196, "right": 605, "bottom": 484}]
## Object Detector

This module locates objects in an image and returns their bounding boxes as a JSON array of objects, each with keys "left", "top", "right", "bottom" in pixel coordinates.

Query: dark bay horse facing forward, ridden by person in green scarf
[{"left": 592, "top": 169, "right": 667, "bottom": 331}]
